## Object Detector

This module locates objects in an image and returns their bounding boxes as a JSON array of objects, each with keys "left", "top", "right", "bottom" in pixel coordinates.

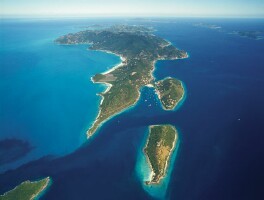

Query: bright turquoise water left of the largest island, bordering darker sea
[{"left": 0, "top": 21, "right": 120, "bottom": 170}]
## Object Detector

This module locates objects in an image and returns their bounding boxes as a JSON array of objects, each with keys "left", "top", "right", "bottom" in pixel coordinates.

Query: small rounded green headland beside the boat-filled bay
[{"left": 155, "top": 77, "right": 184, "bottom": 110}]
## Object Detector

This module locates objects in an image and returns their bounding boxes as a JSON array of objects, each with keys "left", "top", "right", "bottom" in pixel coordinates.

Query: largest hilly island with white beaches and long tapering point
[{"left": 55, "top": 25, "right": 188, "bottom": 137}]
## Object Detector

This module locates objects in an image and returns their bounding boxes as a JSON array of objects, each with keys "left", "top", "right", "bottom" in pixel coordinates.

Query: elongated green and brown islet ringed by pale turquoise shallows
[{"left": 144, "top": 125, "right": 178, "bottom": 185}]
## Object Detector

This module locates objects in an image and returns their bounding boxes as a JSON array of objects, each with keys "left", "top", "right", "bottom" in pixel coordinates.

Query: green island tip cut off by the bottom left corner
[{"left": 0, "top": 177, "right": 51, "bottom": 200}]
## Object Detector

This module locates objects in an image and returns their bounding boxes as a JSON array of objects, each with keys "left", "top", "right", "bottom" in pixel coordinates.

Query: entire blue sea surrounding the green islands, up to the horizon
[{"left": 0, "top": 18, "right": 264, "bottom": 200}]
